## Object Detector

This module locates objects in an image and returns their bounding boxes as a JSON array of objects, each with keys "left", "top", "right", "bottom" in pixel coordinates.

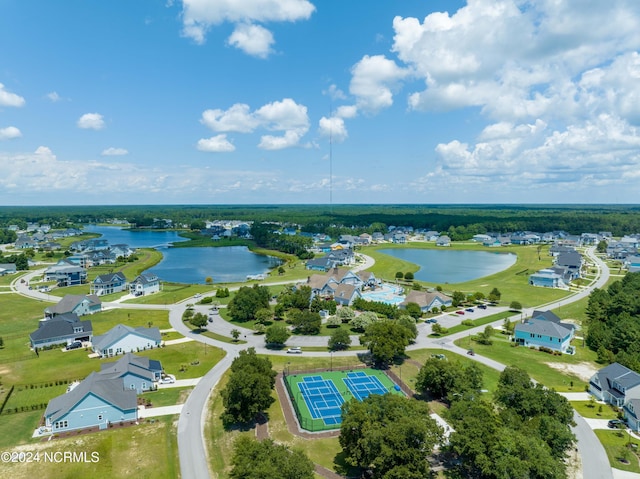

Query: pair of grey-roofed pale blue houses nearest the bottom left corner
[{"left": 44, "top": 353, "right": 163, "bottom": 434}]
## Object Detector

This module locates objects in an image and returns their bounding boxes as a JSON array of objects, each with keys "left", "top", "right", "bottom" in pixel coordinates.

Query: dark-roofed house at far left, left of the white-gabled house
[{"left": 29, "top": 313, "right": 93, "bottom": 349}]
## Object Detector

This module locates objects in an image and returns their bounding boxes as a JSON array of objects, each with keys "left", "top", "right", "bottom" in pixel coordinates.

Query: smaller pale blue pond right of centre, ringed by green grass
[{"left": 379, "top": 248, "right": 516, "bottom": 284}]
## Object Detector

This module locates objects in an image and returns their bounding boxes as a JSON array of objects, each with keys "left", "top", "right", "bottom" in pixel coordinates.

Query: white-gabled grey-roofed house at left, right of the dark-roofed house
[{"left": 93, "top": 324, "right": 162, "bottom": 358}]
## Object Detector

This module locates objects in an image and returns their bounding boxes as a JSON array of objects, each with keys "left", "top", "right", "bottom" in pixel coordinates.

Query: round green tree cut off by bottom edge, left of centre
[{"left": 229, "top": 436, "right": 314, "bottom": 479}]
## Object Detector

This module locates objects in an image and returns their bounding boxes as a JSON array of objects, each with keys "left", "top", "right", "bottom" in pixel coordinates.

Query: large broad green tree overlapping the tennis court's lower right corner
[{"left": 339, "top": 394, "right": 442, "bottom": 479}]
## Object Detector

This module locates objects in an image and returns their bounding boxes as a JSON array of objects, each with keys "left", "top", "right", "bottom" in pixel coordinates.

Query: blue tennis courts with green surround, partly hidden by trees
[{"left": 285, "top": 369, "right": 402, "bottom": 431}]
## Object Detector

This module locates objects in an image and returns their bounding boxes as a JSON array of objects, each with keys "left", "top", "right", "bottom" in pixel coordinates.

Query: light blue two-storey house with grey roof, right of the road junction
[{"left": 513, "top": 311, "right": 575, "bottom": 353}]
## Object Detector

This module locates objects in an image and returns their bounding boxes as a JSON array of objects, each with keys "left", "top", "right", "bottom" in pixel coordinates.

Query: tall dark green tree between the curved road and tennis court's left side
[{"left": 221, "top": 348, "right": 276, "bottom": 425}]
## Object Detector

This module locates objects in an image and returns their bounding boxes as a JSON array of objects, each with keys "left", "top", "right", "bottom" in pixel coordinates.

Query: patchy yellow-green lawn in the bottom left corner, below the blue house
[{"left": 0, "top": 415, "right": 180, "bottom": 479}]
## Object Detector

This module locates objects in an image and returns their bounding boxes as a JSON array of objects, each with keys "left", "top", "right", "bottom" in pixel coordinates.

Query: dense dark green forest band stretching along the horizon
[{"left": 0, "top": 205, "right": 640, "bottom": 239}]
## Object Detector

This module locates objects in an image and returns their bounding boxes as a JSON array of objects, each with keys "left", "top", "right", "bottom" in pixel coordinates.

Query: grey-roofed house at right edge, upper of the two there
[{"left": 589, "top": 363, "right": 640, "bottom": 412}]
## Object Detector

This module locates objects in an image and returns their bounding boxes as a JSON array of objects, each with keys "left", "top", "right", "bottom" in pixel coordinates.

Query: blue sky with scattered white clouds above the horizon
[{"left": 0, "top": 0, "right": 640, "bottom": 205}]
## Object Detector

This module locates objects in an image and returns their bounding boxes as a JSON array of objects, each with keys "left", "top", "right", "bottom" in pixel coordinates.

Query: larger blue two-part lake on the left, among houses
[{"left": 84, "top": 225, "right": 281, "bottom": 284}]
